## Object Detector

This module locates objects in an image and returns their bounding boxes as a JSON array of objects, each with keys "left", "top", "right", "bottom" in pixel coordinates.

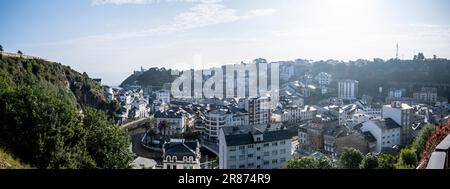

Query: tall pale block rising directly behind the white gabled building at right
[{"left": 382, "top": 101, "right": 413, "bottom": 146}]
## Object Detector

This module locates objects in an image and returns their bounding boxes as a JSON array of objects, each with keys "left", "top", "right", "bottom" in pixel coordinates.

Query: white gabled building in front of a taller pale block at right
[{"left": 361, "top": 118, "right": 401, "bottom": 153}]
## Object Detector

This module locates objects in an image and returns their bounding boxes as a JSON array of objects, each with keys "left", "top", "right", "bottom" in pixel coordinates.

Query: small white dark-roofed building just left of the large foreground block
[{"left": 162, "top": 139, "right": 201, "bottom": 169}]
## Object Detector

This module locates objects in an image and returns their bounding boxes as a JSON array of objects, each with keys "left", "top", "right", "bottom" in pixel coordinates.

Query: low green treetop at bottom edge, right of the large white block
[{"left": 285, "top": 156, "right": 333, "bottom": 169}]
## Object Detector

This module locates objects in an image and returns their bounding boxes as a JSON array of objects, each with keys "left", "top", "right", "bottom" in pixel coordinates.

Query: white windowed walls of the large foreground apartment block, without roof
[{"left": 219, "top": 128, "right": 292, "bottom": 169}]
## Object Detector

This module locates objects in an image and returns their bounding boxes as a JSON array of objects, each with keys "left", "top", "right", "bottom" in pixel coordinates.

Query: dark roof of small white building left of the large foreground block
[{"left": 163, "top": 141, "right": 198, "bottom": 160}]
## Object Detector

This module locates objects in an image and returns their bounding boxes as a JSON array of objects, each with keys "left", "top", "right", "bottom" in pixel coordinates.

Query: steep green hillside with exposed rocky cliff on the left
[{"left": 0, "top": 56, "right": 132, "bottom": 168}]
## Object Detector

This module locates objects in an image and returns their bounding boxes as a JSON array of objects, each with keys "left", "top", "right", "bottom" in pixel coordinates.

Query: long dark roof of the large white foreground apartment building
[{"left": 223, "top": 127, "right": 291, "bottom": 146}]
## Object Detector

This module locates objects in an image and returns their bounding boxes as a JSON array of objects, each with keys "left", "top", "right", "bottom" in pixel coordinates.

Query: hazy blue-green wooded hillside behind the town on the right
[{"left": 293, "top": 58, "right": 450, "bottom": 98}]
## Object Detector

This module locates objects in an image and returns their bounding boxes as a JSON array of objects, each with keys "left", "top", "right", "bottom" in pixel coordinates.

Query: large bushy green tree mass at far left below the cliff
[{"left": 0, "top": 84, "right": 95, "bottom": 169}]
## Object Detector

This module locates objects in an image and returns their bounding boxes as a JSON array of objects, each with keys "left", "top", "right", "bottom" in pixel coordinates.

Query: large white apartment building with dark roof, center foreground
[{"left": 219, "top": 126, "right": 292, "bottom": 169}]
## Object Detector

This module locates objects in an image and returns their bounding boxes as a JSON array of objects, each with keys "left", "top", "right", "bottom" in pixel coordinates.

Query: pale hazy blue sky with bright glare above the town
[{"left": 0, "top": 0, "right": 450, "bottom": 85}]
